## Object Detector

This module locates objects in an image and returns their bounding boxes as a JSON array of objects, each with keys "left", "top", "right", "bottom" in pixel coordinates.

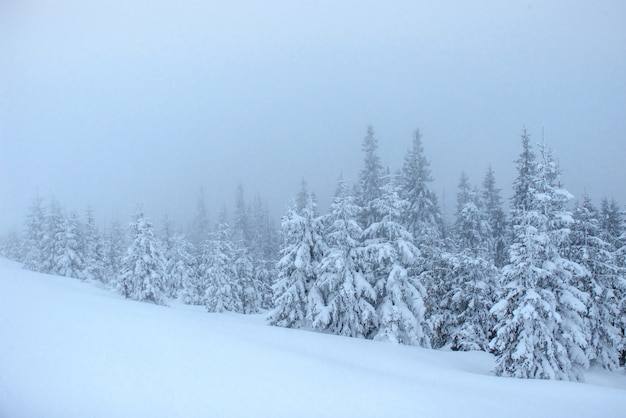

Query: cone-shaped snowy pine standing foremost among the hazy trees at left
[{"left": 119, "top": 208, "right": 167, "bottom": 305}]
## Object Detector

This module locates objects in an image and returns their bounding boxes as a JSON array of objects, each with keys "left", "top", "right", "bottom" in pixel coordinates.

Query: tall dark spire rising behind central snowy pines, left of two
[{"left": 357, "top": 125, "right": 384, "bottom": 228}]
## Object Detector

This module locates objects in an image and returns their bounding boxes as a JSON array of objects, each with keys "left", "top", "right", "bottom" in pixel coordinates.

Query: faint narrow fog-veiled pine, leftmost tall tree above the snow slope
[{"left": 24, "top": 196, "right": 47, "bottom": 272}]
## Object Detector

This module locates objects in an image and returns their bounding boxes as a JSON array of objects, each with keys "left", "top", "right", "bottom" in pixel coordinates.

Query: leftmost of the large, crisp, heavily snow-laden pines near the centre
[{"left": 268, "top": 193, "right": 324, "bottom": 328}]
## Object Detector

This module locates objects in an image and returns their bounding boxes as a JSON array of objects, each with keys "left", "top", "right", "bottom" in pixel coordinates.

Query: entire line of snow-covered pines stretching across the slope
[{"left": 2, "top": 126, "right": 626, "bottom": 380}]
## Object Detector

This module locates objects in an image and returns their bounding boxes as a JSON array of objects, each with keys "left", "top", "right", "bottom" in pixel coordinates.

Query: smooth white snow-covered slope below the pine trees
[{"left": 0, "top": 255, "right": 626, "bottom": 418}]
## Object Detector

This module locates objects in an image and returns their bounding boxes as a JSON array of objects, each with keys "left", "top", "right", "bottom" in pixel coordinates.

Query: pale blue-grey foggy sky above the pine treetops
[{"left": 0, "top": 0, "right": 626, "bottom": 231}]
